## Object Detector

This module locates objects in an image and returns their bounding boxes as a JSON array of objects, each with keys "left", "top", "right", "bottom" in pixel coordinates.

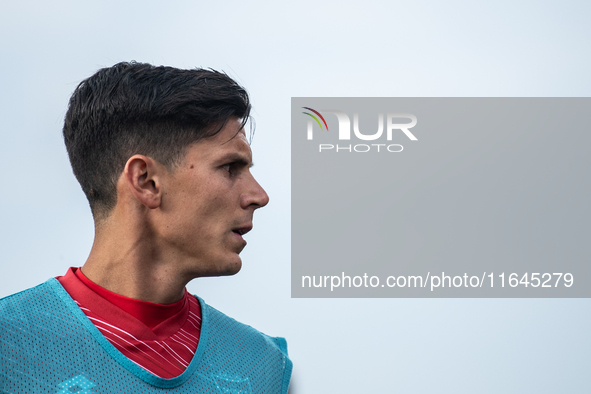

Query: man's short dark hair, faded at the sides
[{"left": 63, "top": 62, "right": 251, "bottom": 220}]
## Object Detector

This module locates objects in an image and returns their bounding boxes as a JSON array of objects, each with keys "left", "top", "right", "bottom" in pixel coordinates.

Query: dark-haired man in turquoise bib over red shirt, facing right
[{"left": 0, "top": 63, "right": 291, "bottom": 393}]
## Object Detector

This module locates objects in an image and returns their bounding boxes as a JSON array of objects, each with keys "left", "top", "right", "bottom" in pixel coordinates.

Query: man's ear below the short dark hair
[{"left": 123, "top": 155, "right": 164, "bottom": 209}]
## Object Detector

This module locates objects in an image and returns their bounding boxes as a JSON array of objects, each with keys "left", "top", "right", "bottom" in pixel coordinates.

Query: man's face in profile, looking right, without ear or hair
[{"left": 159, "top": 118, "right": 269, "bottom": 277}]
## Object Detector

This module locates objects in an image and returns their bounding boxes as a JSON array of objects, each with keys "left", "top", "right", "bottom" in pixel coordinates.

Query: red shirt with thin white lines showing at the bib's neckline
[{"left": 56, "top": 267, "right": 201, "bottom": 379}]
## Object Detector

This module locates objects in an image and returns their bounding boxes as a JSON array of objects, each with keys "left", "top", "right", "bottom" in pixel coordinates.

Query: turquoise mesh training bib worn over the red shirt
[{"left": 0, "top": 279, "right": 292, "bottom": 394}]
